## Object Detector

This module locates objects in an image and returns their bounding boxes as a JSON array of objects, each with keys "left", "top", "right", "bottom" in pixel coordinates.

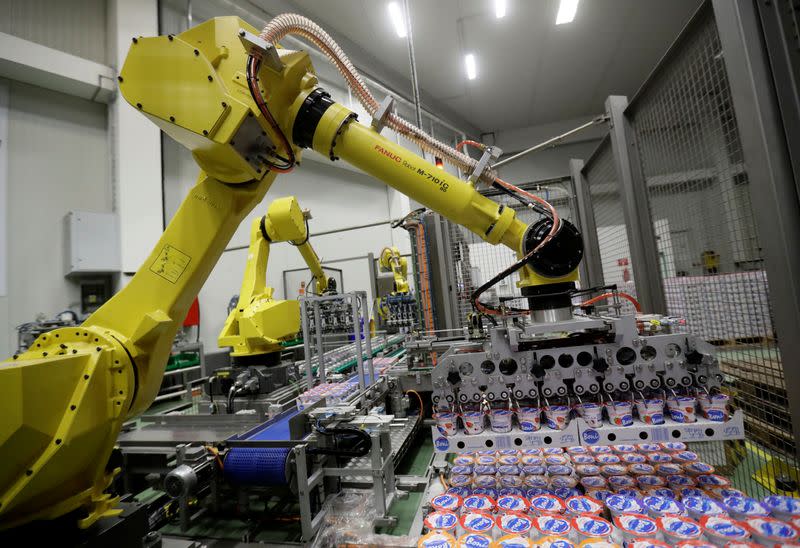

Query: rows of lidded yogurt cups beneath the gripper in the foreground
[{"left": 419, "top": 442, "right": 800, "bottom": 548}]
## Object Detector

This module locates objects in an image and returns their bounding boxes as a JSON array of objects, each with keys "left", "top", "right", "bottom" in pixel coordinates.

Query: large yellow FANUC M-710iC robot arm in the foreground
[{"left": 0, "top": 15, "right": 580, "bottom": 528}]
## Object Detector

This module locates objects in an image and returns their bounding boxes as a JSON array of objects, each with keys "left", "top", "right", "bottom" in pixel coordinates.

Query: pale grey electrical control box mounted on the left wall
[{"left": 64, "top": 211, "right": 121, "bottom": 276}]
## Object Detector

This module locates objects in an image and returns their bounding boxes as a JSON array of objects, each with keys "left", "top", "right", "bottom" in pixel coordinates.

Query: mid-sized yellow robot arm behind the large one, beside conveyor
[{"left": 218, "top": 196, "right": 328, "bottom": 360}]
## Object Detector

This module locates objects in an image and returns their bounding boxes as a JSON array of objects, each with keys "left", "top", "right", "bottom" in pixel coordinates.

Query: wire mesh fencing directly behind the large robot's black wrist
[{"left": 440, "top": 177, "right": 578, "bottom": 327}]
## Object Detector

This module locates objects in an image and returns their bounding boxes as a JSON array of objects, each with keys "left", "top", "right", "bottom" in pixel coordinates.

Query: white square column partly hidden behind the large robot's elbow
[{"left": 108, "top": 0, "right": 164, "bottom": 274}]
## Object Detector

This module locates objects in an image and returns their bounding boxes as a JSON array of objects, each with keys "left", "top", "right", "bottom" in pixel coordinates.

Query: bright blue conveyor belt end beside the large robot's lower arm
[{"left": 225, "top": 409, "right": 300, "bottom": 486}]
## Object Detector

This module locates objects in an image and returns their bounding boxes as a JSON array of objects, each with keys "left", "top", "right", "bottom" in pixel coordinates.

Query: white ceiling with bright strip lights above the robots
[{"left": 262, "top": 0, "right": 700, "bottom": 131}]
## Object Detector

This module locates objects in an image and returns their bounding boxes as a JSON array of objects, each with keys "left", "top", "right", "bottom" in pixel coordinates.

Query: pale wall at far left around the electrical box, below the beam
[{"left": 0, "top": 82, "right": 111, "bottom": 356}]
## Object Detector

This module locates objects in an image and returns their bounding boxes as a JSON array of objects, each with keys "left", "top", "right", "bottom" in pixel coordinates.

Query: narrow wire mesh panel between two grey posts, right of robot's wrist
[{"left": 583, "top": 136, "right": 637, "bottom": 314}]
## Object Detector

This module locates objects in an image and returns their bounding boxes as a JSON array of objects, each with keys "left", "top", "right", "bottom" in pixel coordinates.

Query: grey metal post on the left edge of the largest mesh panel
[{"left": 606, "top": 95, "right": 667, "bottom": 314}]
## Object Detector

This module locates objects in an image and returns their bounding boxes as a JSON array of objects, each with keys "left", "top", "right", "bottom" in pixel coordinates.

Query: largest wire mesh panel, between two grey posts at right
[{"left": 624, "top": 4, "right": 797, "bottom": 495}]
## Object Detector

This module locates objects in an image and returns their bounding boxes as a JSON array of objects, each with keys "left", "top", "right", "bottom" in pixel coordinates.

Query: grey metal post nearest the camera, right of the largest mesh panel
[{"left": 713, "top": 0, "right": 800, "bottom": 454}]
